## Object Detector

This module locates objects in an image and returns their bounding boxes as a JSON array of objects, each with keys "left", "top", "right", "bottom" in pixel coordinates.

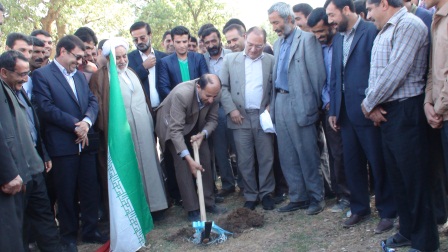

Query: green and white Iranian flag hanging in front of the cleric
[{"left": 107, "top": 44, "right": 154, "bottom": 252}]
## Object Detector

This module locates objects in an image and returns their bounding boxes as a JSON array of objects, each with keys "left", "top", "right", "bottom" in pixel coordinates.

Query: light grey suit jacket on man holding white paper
[{"left": 220, "top": 52, "right": 274, "bottom": 129}]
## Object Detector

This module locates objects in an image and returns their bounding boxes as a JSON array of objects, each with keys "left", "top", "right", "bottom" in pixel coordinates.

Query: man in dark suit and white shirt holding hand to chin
[{"left": 128, "top": 21, "right": 168, "bottom": 111}]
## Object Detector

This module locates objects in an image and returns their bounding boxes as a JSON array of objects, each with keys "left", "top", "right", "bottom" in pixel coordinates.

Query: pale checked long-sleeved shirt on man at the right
[{"left": 363, "top": 7, "right": 428, "bottom": 112}]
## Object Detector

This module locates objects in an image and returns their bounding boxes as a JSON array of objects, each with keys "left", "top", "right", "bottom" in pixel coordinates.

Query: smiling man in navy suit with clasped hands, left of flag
[{"left": 32, "top": 35, "right": 107, "bottom": 250}]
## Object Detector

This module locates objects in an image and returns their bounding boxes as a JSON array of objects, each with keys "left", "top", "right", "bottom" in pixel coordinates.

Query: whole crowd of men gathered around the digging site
[{"left": 0, "top": 0, "right": 448, "bottom": 251}]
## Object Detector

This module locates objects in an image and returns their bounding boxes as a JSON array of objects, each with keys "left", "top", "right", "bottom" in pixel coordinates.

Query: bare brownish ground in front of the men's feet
[{"left": 78, "top": 193, "right": 448, "bottom": 252}]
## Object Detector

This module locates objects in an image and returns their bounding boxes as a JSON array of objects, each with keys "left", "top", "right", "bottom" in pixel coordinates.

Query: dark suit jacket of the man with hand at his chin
[{"left": 128, "top": 50, "right": 168, "bottom": 100}]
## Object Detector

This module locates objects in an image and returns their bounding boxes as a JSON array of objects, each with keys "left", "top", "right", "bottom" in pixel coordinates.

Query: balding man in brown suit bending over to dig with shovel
[{"left": 155, "top": 74, "right": 225, "bottom": 221}]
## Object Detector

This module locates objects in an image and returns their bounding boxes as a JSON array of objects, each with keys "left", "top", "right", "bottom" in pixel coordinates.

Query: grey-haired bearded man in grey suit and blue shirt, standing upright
[{"left": 268, "top": 2, "right": 326, "bottom": 215}]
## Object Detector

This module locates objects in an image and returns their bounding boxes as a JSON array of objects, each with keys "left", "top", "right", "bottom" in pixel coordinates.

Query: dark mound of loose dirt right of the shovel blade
[{"left": 216, "top": 208, "right": 264, "bottom": 237}]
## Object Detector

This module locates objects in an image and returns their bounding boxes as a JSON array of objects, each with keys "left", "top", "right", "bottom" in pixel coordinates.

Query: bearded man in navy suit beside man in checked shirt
[{"left": 325, "top": 0, "right": 396, "bottom": 234}]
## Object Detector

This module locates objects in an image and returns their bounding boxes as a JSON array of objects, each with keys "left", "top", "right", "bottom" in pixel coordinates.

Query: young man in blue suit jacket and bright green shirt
[{"left": 159, "top": 26, "right": 209, "bottom": 100}]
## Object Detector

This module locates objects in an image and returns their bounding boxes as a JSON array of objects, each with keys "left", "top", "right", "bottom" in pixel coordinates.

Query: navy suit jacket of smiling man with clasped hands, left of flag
[{"left": 32, "top": 62, "right": 98, "bottom": 157}]
